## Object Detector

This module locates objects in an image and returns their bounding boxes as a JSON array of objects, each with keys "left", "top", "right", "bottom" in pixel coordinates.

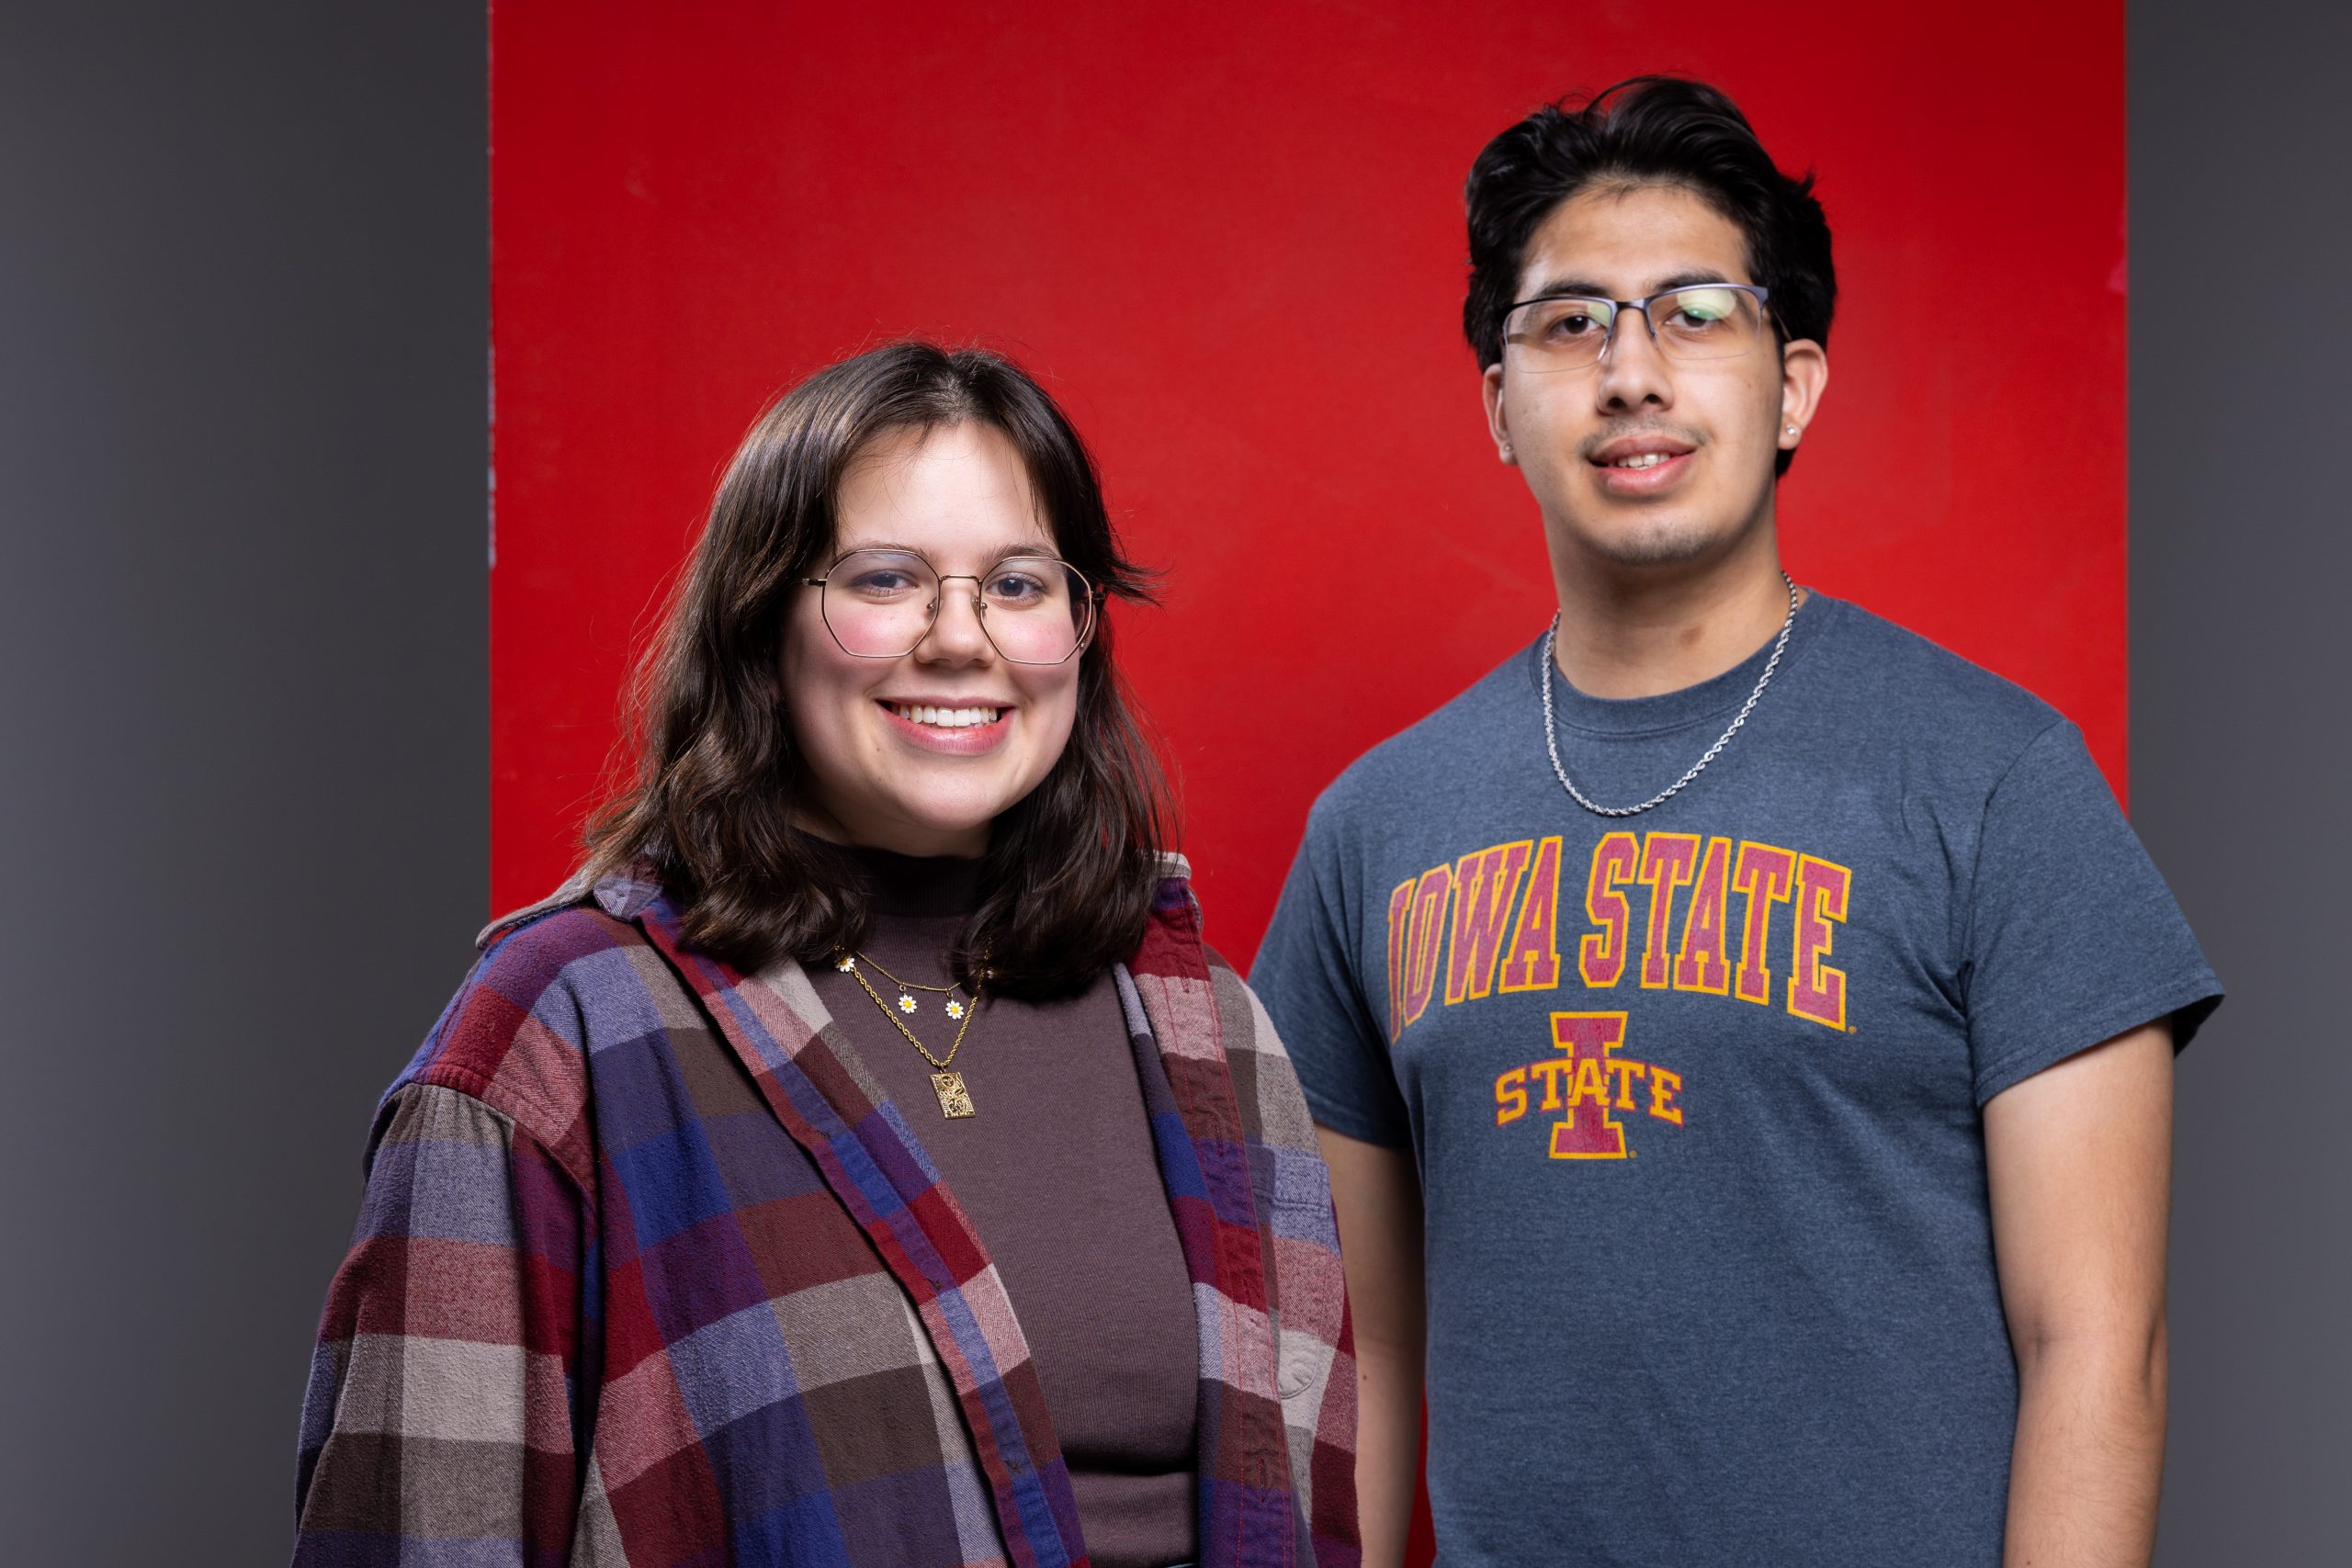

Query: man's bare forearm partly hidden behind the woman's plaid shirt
[{"left": 1315, "top": 1126, "right": 1425, "bottom": 1568}]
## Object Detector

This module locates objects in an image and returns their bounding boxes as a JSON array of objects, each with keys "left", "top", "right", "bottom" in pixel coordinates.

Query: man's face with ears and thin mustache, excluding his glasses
[{"left": 1484, "top": 186, "right": 1830, "bottom": 567}]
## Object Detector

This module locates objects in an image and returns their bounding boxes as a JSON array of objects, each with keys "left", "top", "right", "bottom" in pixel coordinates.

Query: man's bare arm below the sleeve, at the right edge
[{"left": 1984, "top": 1022, "right": 2173, "bottom": 1568}]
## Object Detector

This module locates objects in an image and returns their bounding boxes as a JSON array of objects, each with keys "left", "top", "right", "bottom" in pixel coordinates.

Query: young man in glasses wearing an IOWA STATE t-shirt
[{"left": 1251, "top": 80, "right": 2221, "bottom": 1568}]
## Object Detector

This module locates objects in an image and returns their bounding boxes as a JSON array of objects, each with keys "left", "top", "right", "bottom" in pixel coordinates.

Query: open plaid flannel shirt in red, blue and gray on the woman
[{"left": 294, "top": 863, "right": 1357, "bottom": 1568}]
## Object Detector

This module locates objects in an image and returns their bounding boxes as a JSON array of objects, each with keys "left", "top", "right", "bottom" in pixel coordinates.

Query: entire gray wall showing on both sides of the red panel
[{"left": 0, "top": 0, "right": 2352, "bottom": 1568}]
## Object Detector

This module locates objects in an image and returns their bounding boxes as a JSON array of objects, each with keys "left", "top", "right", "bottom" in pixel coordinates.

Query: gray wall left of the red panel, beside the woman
[{"left": 0, "top": 0, "right": 489, "bottom": 1568}]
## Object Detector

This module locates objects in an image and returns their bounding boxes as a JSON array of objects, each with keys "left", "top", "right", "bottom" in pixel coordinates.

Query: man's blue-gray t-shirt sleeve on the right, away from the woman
[{"left": 1964, "top": 719, "right": 2221, "bottom": 1105}]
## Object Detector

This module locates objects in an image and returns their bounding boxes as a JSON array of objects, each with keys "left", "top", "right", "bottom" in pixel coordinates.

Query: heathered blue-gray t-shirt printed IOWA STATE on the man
[{"left": 1251, "top": 594, "right": 2221, "bottom": 1568}]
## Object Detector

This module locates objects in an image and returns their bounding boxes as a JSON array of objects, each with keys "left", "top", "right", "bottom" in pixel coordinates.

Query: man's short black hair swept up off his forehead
[{"left": 1463, "top": 75, "right": 1837, "bottom": 472}]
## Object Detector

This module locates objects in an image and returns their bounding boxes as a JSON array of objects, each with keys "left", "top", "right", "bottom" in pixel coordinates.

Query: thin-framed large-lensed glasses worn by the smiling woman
[{"left": 802, "top": 550, "right": 1103, "bottom": 665}]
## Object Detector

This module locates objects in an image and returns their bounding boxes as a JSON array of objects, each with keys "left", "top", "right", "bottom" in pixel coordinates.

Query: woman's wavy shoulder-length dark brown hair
[{"left": 588, "top": 344, "right": 1169, "bottom": 997}]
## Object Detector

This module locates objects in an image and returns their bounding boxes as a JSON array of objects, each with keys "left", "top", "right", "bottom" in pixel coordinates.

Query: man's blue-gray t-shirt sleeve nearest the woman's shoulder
[{"left": 1249, "top": 797, "right": 1411, "bottom": 1149}]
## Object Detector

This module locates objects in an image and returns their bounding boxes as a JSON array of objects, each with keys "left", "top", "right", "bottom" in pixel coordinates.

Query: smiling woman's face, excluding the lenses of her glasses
[{"left": 783, "top": 423, "right": 1082, "bottom": 856}]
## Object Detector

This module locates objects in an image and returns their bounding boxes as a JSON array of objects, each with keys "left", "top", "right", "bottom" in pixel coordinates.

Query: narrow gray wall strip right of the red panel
[{"left": 2135, "top": 0, "right": 2352, "bottom": 1568}]
